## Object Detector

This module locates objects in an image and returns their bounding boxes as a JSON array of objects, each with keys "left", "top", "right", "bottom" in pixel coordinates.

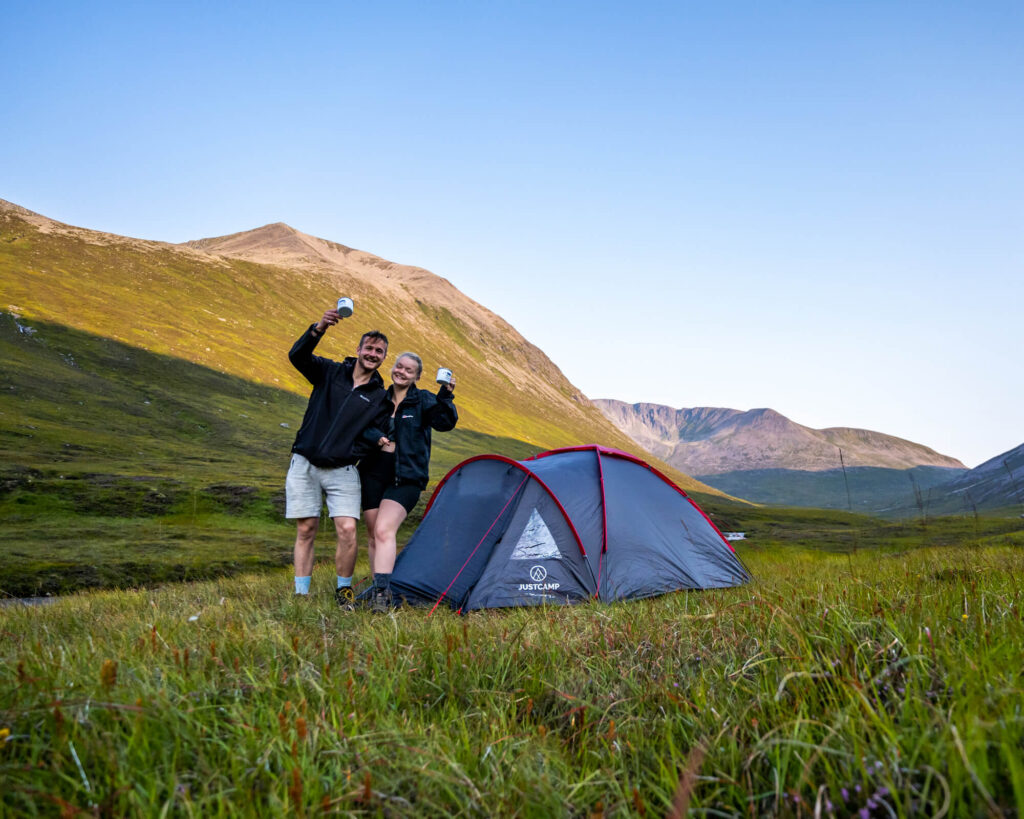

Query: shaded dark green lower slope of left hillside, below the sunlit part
[{"left": 0, "top": 313, "right": 537, "bottom": 596}]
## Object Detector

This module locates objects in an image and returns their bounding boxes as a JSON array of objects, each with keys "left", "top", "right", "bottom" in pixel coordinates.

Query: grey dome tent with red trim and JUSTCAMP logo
[{"left": 380, "top": 445, "right": 750, "bottom": 611}]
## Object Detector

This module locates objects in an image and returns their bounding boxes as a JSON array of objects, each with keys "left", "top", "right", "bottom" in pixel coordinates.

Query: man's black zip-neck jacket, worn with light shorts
[{"left": 288, "top": 325, "right": 392, "bottom": 468}]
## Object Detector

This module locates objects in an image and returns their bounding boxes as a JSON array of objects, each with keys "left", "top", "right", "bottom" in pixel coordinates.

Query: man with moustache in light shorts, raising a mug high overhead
[{"left": 285, "top": 308, "right": 392, "bottom": 608}]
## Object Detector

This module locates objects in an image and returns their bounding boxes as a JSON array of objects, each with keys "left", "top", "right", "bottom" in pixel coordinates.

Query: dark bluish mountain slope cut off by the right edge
[{"left": 909, "top": 443, "right": 1024, "bottom": 516}]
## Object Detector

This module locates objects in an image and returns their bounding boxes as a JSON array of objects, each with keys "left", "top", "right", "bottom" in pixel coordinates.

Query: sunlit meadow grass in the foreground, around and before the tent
[{"left": 0, "top": 538, "right": 1024, "bottom": 816}]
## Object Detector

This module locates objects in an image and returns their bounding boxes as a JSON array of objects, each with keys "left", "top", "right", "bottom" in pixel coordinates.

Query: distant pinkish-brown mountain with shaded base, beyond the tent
[{"left": 594, "top": 398, "right": 967, "bottom": 512}]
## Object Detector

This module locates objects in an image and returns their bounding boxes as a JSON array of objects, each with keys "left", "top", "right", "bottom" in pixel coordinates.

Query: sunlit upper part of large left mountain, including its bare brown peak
[{"left": 0, "top": 200, "right": 718, "bottom": 493}]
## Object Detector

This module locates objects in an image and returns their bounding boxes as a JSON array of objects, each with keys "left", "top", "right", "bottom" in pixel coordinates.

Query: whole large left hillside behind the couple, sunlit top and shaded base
[{"left": 0, "top": 201, "right": 733, "bottom": 596}]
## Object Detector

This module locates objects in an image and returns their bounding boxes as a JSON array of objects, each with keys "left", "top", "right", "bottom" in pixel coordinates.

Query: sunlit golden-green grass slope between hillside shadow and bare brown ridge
[{"left": 0, "top": 202, "right": 582, "bottom": 444}]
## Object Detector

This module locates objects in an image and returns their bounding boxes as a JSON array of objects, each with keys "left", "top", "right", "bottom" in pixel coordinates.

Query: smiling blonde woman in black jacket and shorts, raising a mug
[{"left": 359, "top": 352, "right": 459, "bottom": 611}]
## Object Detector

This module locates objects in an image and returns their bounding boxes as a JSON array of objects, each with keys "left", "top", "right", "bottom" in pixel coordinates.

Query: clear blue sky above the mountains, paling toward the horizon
[{"left": 0, "top": 0, "right": 1024, "bottom": 466}]
